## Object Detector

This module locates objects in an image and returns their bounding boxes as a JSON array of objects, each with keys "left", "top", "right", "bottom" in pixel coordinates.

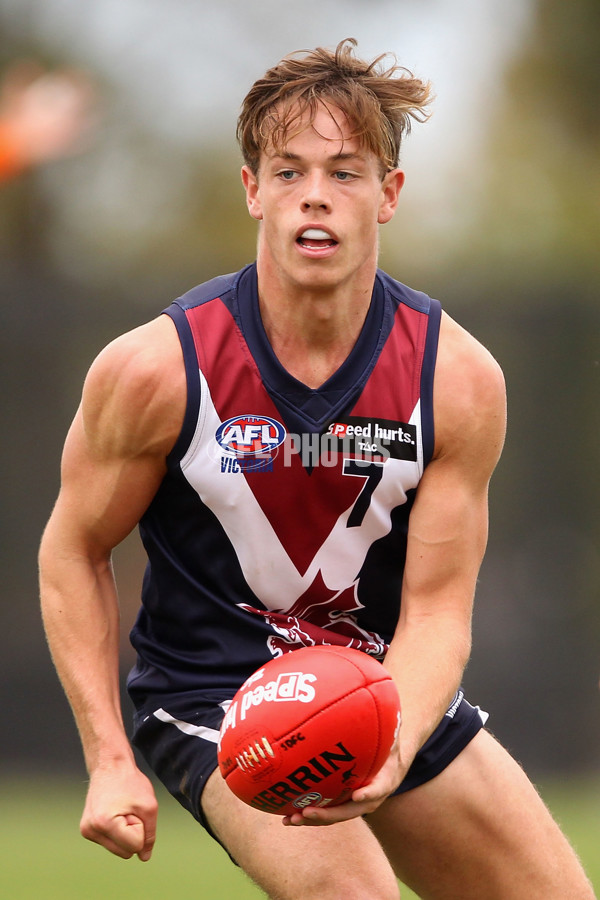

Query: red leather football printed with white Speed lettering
[{"left": 218, "top": 647, "right": 400, "bottom": 816}]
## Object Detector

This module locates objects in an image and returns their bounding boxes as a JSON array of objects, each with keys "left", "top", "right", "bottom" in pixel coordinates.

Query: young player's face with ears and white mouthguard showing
[{"left": 242, "top": 105, "right": 404, "bottom": 292}]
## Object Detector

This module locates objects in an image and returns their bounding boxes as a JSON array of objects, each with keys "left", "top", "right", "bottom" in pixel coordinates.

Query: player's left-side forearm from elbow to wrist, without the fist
[{"left": 40, "top": 525, "right": 133, "bottom": 772}]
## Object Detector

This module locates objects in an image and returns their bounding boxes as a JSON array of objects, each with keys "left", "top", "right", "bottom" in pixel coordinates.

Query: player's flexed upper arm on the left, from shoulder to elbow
[{"left": 45, "top": 316, "right": 186, "bottom": 558}]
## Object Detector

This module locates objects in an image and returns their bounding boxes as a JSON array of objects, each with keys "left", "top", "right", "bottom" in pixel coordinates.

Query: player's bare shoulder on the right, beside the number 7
[{"left": 434, "top": 314, "right": 506, "bottom": 469}]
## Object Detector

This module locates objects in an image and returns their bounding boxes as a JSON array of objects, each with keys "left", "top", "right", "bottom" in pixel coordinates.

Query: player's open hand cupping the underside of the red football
[{"left": 282, "top": 738, "right": 407, "bottom": 825}]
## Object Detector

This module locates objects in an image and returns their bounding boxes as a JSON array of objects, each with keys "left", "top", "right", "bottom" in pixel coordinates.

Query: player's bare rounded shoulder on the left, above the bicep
[{"left": 81, "top": 315, "right": 186, "bottom": 457}]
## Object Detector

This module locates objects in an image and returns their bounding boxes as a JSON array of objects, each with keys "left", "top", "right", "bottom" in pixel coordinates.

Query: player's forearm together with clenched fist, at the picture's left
[{"left": 40, "top": 519, "right": 157, "bottom": 860}]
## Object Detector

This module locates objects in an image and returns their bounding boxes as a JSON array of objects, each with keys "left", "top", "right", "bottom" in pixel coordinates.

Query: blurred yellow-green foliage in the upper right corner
[{"left": 468, "top": 0, "right": 600, "bottom": 284}]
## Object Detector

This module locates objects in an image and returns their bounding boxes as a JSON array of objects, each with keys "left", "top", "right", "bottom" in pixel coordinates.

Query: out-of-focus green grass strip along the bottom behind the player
[{"left": 0, "top": 776, "right": 600, "bottom": 900}]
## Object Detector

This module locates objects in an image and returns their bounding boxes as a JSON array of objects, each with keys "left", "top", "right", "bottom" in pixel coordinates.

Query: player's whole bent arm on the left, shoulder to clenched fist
[{"left": 40, "top": 317, "right": 185, "bottom": 859}]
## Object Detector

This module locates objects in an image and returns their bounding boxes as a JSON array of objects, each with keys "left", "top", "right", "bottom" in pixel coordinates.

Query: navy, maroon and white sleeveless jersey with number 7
[{"left": 128, "top": 265, "right": 440, "bottom": 709}]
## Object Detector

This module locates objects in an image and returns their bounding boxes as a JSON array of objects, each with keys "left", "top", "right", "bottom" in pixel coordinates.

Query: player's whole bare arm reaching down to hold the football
[{"left": 286, "top": 316, "right": 506, "bottom": 824}]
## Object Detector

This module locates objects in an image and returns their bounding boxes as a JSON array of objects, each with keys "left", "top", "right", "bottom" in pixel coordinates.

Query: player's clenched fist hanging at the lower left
[{"left": 80, "top": 766, "right": 158, "bottom": 862}]
